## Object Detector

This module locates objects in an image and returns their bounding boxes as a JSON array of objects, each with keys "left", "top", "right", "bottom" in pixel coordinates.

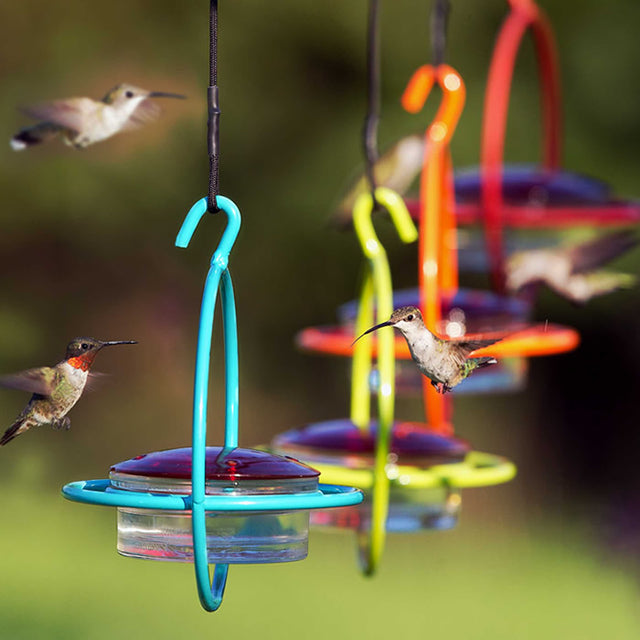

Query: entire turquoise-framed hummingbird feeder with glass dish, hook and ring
[{"left": 62, "top": 196, "right": 363, "bottom": 611}]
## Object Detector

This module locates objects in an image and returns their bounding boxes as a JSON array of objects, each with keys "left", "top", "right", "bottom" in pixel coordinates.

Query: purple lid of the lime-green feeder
[{"left": 273, "top": 419, "right": 470, "bottom": 468}]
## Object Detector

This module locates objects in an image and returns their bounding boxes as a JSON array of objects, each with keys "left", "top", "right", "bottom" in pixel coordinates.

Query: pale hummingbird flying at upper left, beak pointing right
[{"left": 11, "top": 84, "right": 185, "bottom": 151}]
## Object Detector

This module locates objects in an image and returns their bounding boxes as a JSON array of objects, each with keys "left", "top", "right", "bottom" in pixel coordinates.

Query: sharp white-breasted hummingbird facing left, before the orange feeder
[{"left": 354, "top": 307, "right": 500, "bottom": 394}]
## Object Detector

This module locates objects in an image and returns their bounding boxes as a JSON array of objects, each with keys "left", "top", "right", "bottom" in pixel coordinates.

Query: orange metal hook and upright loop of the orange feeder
[{"left": 402, "top": 64, "right": 465, "bottom": 433}]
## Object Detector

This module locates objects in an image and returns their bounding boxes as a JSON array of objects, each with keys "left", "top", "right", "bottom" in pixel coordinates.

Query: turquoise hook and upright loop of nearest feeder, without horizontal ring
[{"left": 176, "top": 196, "right": 240, "bottom": 611}]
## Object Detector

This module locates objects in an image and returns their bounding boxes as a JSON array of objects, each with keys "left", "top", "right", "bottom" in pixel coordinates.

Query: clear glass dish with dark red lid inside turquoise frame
[{"left": 109, "top": 447, "right": 320, "bottom": 564}]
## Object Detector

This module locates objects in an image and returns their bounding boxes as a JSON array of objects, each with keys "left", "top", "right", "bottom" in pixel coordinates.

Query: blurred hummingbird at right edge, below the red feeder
[{"left": 505, "top": 230, "right": 638, "bottom": 304}]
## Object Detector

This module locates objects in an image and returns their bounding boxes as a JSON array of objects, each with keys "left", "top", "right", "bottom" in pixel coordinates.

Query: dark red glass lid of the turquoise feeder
[{"left": 111, "top": 447, "right": 320, "bottom": 481}]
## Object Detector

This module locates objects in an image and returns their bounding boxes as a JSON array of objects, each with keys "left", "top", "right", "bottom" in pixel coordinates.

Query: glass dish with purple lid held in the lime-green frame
[{"left": 273, "top": 420, "right": 470, "bottom": 533}]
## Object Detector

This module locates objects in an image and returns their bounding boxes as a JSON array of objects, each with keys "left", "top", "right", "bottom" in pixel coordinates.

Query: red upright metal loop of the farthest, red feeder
[{"left": 480, "top": 0, "right": 562, "bottom": 292}]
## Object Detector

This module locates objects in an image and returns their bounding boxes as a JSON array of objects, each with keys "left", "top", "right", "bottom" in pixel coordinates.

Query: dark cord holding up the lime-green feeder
[{"left": 363, "top": 0, "right": 380, "bottom": 208}]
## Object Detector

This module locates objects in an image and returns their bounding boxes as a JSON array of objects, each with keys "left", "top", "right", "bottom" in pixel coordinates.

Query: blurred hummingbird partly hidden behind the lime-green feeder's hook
[{"left": 333, "top": 135, "right": 424, "bottom": 227}]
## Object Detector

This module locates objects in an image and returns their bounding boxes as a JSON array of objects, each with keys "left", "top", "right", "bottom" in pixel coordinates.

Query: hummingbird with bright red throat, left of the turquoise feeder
[{"left": 0, "top": 338, "right": 137, "bottom": 446}]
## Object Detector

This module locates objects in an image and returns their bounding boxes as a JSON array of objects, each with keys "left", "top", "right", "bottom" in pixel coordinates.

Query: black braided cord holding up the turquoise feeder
[{"left": 207, "top": 0, "right": 220, "bottom": 213}]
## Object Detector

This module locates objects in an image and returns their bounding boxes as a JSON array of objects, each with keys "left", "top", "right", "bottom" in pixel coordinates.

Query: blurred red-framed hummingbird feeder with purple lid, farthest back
[{"left": 407, "top": 0, "right": 640, "bottom": 293}]
